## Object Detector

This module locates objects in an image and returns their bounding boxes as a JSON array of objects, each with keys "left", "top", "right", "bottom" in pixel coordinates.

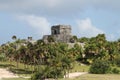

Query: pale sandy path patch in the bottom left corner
[{"left": 0, "top": 68, "right": 19, "bottom": 80}]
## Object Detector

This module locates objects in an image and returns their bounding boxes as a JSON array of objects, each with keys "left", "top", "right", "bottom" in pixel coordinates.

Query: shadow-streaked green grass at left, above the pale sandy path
[{"left": 0, "top": 61, "right": 33, "bottom": 76}]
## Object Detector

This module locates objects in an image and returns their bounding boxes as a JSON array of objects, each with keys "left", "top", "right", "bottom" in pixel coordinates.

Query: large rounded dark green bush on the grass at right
[{"left": 89, "top": 60, "right": 111, "bottom": 74}]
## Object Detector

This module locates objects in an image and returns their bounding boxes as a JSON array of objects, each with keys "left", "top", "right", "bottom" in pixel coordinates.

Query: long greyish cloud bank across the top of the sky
[{"left": 0, "top": 0, "right": 120, "bottom": 17}]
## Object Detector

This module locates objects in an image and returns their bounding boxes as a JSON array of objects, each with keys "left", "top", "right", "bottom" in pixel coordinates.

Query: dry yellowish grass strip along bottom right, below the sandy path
[{"left": 60, "top": 74, "right": 120, "bottom": 80}]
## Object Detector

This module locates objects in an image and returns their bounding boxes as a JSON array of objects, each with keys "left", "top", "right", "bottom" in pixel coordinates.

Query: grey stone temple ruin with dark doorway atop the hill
[{"left": 43, "top": 25, "right": 72, "bottom": 43}]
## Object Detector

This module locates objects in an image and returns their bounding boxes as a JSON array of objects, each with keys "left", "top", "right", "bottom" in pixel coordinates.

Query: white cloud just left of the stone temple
[{"left": 18, "top": 15, "right": 50, "bottom": 37}]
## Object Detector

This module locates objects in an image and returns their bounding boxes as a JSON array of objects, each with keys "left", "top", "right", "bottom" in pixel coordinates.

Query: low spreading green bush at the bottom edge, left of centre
[{"left": 30, "top": 67, "right": 64, "bottom": 80}]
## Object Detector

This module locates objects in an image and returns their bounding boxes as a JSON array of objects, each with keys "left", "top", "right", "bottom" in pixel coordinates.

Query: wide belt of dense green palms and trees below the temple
[{"left": 0, "top": 34, "right": 120, "bottom": 78}]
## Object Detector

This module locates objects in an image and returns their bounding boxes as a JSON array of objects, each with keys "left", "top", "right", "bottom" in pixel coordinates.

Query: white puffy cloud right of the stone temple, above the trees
[{"left": 77, "top": 18, "right": 104, "bottom": 37}]
